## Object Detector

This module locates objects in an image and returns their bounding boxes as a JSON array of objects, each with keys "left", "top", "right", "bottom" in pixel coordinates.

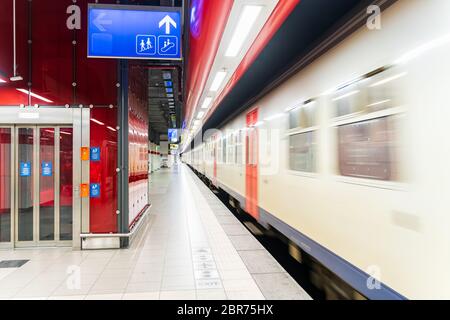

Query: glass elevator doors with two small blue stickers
[{"left": 14, "top": 126, "right": 73, "bottom": 247}]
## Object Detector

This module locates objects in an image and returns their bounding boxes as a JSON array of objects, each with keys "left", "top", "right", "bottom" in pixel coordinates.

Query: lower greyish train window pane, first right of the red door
[{"left": 289, "top": 131, "right": 316, "bottom": 172}]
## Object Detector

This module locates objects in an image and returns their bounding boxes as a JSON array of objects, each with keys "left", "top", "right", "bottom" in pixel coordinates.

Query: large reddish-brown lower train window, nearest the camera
[{"left": 337, "top": 117, "right": 396, "bottom": 180}]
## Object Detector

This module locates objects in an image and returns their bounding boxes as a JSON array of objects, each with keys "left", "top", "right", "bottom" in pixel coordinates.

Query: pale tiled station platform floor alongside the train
[{"left": 0, "top": 164, "right": 310, "bottom": 300}]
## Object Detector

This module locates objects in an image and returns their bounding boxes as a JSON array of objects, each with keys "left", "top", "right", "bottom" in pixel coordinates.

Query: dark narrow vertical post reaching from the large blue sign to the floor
[{"left": 117, "top": 60, "right": 129, "bottom": 248}]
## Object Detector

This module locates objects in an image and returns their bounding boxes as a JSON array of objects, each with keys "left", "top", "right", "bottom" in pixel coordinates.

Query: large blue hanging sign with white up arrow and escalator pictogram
[{"left": 88, "top": 4, "right": 182, "bottom": 60}]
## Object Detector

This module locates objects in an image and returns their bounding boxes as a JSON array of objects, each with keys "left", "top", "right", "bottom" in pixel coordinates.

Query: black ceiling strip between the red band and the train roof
[{"left": 202, "top": 0, "right": 392, "bottom": 131}]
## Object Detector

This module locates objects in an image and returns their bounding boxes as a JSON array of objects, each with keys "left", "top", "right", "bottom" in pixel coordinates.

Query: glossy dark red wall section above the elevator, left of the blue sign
[{"left": 0, "top": 0, "right": 117, "bottom": 105}]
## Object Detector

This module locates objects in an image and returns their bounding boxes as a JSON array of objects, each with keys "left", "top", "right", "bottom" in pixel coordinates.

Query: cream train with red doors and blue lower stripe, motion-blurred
[{"left": 183, "top": 0, "right": 450, "bottom": 299}]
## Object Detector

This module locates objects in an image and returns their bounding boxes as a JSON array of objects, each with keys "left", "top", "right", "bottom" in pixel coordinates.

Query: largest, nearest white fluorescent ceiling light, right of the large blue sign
[{"left": 225, "top": 5, "right": 262, "bottom": 57}]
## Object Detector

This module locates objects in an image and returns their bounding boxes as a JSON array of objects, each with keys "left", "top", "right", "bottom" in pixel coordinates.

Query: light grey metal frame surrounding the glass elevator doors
[{"left": 0, "top": 106, "right": 84, "bottom": 250}]
